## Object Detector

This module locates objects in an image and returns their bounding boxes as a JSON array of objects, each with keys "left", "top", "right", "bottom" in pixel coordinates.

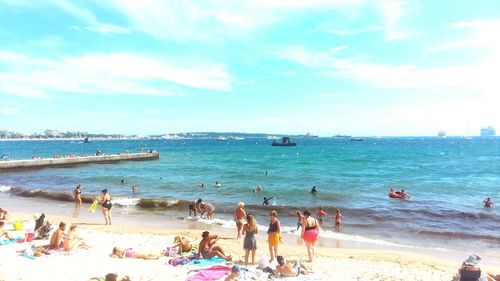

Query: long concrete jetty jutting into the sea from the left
[{"left": 0, "top": 152, "right": 160, "bottom": 173}]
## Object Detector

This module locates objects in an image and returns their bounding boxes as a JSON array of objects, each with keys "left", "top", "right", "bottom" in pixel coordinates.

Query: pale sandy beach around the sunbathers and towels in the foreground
[{"left": 0, "top": 210, "right": 500, "bottom": 280}]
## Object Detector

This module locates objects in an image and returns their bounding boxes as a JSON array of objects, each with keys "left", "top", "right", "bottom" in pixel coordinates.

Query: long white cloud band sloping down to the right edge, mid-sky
[{"left": 280, "top": 44, "right": 500, "bottom": 95}]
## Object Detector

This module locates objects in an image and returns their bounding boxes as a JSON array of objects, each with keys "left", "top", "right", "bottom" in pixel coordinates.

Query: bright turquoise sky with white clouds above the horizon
[{"left": 0, "top": 0, "right": 500, "bottom": 137}]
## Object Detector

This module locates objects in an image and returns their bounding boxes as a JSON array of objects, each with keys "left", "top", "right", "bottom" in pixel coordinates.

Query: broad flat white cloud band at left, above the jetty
[{"left": 0, "top": 52, "right": 231, "bottom": 98}]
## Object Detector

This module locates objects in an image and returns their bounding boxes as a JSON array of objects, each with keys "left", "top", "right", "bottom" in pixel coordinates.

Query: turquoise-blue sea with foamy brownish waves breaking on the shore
[{"left": 0, "top": 137, "right": 500, "bottom": 261}]
